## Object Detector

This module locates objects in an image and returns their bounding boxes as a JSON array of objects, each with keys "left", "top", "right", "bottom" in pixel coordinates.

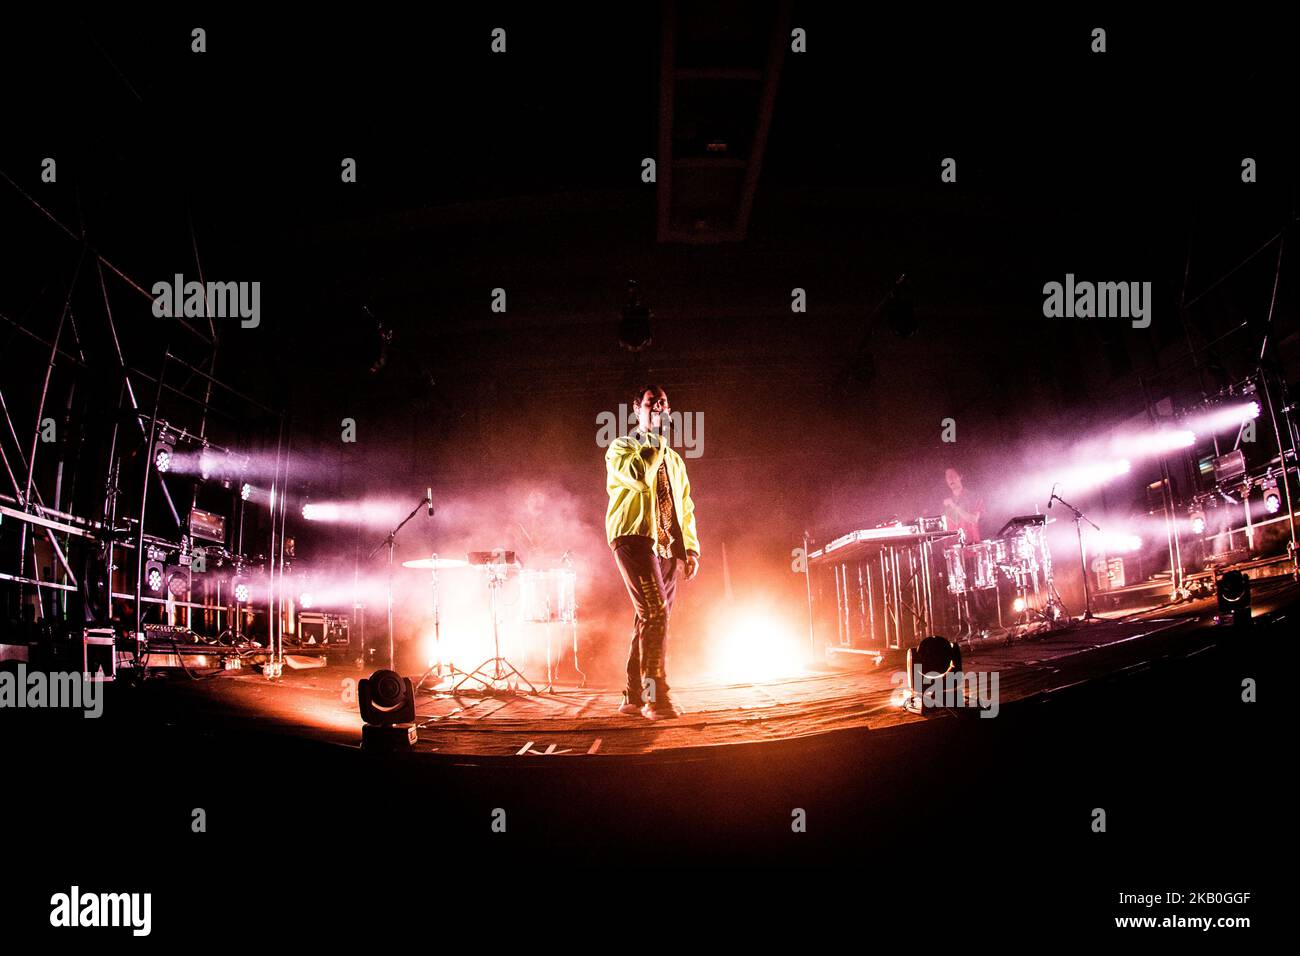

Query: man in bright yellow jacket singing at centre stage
[{"left": 605, "top": 385, "right": 699, "bottom": 721}]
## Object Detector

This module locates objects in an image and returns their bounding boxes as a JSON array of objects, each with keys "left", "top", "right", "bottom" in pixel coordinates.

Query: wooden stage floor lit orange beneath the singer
[{"left": 126, "top": 580, "right": 1300, "bottom": 762}]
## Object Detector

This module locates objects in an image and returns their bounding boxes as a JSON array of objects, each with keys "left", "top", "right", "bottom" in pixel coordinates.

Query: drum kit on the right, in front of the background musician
[{"left": 944, "top": 515, "right": 1065, "bottom": 635}]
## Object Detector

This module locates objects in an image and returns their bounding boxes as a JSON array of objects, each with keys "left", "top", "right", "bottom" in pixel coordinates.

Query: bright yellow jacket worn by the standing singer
[{"left": 605, "top": 436, "right": 699, "bottom": 558}]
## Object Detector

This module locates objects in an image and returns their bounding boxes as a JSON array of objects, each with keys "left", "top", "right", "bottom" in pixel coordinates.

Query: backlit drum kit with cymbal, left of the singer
[{"left": 402, "top": 549, "right": 586, "bottom": 696}]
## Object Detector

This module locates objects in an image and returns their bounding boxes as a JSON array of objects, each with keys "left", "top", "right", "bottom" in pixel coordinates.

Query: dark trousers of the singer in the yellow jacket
[{"left": 614, "top": 536, "right": 677, "bottom": 704}]
